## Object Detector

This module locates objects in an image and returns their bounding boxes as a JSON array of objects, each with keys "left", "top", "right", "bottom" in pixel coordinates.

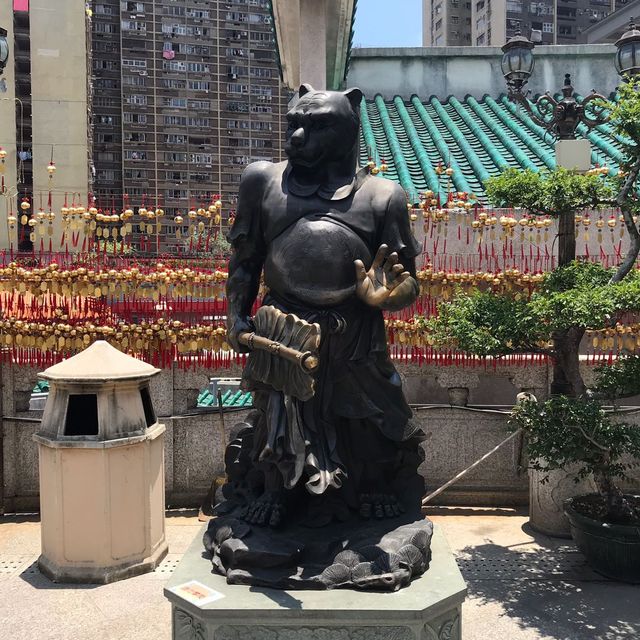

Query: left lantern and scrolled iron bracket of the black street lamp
[{"left": 502, "top": 33, "right": 606, "bottom": 140}]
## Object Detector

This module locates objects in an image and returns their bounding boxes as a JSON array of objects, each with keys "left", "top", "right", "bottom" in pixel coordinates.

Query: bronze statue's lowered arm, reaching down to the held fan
[{"left": 226, "top": 162, "right": 268, "bottom": 352}]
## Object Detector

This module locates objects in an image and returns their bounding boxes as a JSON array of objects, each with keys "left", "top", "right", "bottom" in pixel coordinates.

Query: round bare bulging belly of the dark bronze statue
[{"left": 264, "top": 218, "right": 371, "bottom": 307}]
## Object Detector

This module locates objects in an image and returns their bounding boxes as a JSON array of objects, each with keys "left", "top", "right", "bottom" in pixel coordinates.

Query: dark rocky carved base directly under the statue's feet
[{"left": 203, "top": 516, "right": 433, "bottom": 591}]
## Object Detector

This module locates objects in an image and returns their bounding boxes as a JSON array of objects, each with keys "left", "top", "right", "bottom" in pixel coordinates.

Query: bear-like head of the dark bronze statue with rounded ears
[{"left": 284, "top": 84, "right": 362, "bottom": 169}]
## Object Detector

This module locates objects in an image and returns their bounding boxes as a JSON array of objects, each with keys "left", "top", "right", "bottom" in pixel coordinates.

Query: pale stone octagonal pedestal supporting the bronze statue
[{"left": 165, "top": 526, "right": 467, "bottom": 640}]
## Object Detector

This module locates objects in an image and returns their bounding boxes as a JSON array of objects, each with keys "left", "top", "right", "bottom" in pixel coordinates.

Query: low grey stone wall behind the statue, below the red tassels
[{"left": 0, "top": 363, "right": 640, "bottom": 512}]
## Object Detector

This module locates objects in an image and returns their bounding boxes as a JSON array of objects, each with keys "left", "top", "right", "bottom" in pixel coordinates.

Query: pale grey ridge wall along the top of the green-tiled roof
[{"left": 347, "top": 44, "right": 618, "bottom": 100}]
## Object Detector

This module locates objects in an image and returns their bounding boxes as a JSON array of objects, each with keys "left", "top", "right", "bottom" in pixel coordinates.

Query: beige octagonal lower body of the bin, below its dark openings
[{"left": 34, "top": 424, "right": 167, "bottom": 584}]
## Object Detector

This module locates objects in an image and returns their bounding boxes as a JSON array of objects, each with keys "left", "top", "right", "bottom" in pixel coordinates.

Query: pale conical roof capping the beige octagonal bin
[{"left": 38, "top": 340, "right": 160, "bottom": 383}]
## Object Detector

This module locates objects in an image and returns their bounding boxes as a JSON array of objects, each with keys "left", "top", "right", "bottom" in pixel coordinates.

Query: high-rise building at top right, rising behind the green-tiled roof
[{"left": 423, "top": 0, "right": 627, "bottom": 47}]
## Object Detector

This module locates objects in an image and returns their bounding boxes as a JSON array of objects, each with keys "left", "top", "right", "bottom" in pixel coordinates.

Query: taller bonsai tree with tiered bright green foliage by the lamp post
[{"left": 430, "top": 83, "right": 640, "bottom": 397}]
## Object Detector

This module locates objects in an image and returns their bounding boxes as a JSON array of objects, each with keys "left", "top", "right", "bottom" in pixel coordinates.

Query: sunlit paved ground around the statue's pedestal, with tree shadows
[{"left": 0, "top": 508, "right": 640, "bottom": 640}]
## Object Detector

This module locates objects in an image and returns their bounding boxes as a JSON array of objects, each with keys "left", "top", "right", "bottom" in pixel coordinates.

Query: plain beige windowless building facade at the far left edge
[{"left": 0, "top": 0, "right": 90, "bottom": 250}]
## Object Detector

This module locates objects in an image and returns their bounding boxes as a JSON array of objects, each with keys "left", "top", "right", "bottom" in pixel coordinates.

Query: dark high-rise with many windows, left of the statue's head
[{"left": 91, "top": 0, "right": 289, "bottom": 245}]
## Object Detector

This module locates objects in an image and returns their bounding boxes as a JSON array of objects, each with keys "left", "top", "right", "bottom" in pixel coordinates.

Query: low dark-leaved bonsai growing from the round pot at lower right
[{"left": 510, "top": 396, "right": 640, "bottom": 525}]
